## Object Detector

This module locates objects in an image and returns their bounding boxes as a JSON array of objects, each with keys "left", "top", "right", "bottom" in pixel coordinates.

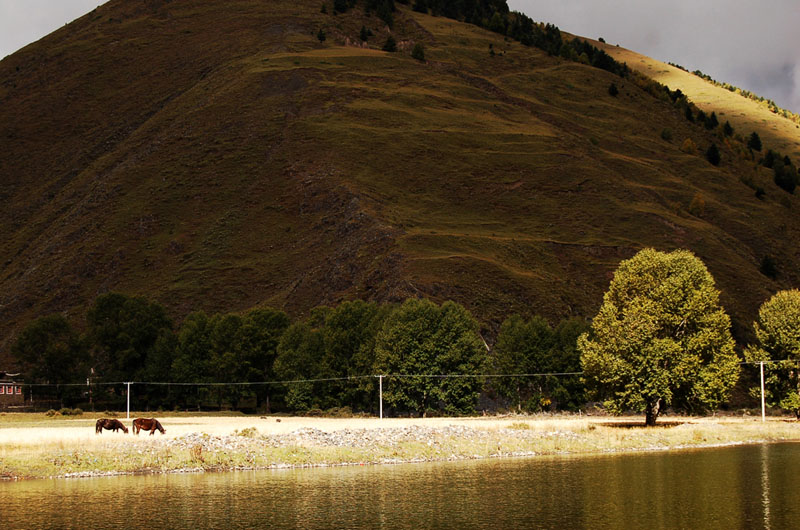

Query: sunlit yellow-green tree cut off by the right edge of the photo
[{"left": 745, "top": 289, "right": 800, "bottom": 419}]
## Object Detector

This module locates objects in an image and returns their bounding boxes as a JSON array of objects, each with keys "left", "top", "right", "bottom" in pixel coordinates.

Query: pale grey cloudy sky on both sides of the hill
[{"left": 0, "top": 0, "right": 800, "bottom": 113}]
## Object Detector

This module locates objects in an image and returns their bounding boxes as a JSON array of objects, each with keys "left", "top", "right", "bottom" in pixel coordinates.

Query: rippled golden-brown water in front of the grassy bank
[{"left": 0, "top": 444, "right": 800, "bottom": 530}]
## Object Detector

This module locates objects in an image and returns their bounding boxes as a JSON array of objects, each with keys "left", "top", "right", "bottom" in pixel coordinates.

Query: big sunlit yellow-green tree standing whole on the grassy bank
[{"left": 578, "top": 249, "right": 739, "bottom": 425}]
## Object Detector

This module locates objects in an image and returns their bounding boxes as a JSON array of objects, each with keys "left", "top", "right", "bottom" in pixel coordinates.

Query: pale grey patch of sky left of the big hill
[{"left": 0, "top": 0, "right": 105, "bottom": 58}]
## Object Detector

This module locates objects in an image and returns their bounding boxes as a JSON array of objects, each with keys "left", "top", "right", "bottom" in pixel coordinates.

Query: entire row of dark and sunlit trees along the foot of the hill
[{"left": 12, "top": 249, "right": 800, "bottom": 425}]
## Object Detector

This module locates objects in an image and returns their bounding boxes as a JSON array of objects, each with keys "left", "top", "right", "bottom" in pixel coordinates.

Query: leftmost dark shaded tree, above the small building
[{"left": 11, "top": 314, "right": 89, "bottom": 384}]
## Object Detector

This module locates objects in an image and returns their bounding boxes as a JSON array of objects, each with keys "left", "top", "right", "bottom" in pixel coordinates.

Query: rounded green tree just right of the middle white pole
[{"left": 375, "top": 299, "right": 487, "bottom": 415}]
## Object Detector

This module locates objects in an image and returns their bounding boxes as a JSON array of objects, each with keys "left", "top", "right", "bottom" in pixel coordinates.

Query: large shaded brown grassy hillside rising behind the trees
[{"left": 0, "top": 0, "right": 800, "bottom": 361}]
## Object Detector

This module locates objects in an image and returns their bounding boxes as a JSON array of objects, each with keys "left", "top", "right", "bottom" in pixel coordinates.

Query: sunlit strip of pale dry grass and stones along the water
[{"left": 0, "top": 415, "right": 800, "bottom": 482}]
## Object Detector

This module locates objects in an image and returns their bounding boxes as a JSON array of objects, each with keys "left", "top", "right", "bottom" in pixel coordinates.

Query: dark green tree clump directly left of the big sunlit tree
[{"left": 491, "top": 315, "right": 588, "bottom": 412}]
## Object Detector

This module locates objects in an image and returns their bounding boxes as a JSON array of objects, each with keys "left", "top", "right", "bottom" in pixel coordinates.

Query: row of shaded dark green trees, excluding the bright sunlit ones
[{"left": 12, "top": 293, "right": 587, "bottom": 415}]
